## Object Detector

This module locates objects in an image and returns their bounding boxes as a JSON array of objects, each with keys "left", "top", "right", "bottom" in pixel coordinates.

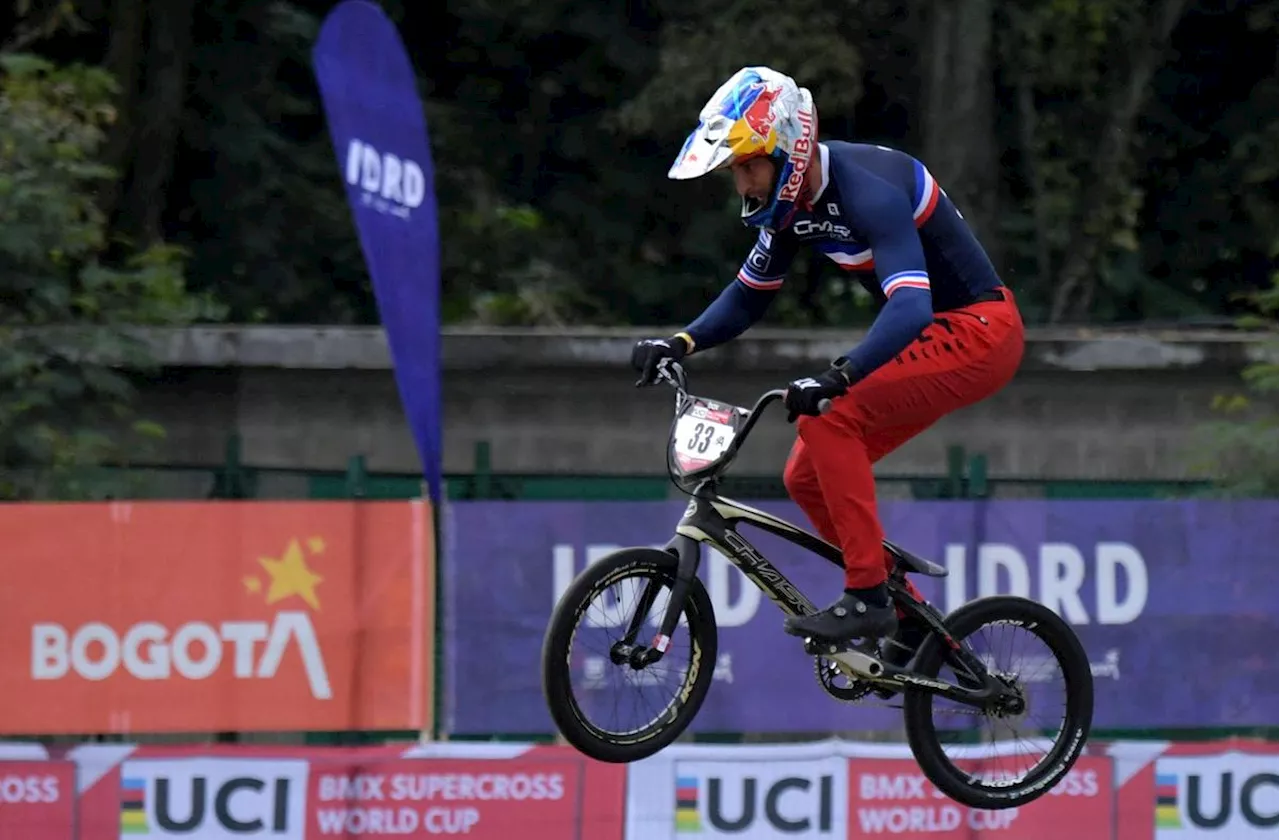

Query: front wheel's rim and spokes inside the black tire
[{"left": 562, "top": 566, "right": 705, "bottom": 744}]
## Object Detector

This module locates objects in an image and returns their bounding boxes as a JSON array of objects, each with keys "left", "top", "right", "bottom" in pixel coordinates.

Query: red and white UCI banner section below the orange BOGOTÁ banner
[{"left": 15, "top": 744, "right": 627, "bottom": 840}]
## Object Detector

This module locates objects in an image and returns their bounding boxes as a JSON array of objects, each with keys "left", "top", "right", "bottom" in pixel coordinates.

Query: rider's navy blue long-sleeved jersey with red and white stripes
[{"left": 685, "top": 141, "right": 1001, "bottom": 378}]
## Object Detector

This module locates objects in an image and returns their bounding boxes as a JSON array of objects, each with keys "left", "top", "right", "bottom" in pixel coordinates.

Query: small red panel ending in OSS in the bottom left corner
[{"left": 0, "top": 761, "right": 76, "bottom": 840}]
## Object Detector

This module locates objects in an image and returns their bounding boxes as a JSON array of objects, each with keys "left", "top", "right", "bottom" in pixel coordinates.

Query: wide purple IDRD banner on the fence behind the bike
[{"left": 442, "top": 501, "right": 1280, "bottom": 734}]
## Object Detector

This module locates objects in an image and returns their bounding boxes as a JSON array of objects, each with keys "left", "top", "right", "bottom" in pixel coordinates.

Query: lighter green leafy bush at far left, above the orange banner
[{"left": 0, "top": 54, "right": 216, "bottom": 499}]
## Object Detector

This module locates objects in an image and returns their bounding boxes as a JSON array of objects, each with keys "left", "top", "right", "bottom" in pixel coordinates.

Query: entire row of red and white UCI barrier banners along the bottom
[{"left": 0, "top": 740, "right": 1280, "bottom": 840}]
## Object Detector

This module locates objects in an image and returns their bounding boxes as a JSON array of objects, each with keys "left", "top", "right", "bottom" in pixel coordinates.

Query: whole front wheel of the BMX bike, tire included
[{"left": 543, "top": 548, "right": 717, "bottom": 763}]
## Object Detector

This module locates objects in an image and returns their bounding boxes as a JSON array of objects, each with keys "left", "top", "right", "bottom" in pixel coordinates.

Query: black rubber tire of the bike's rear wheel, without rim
[{"left": 902, "top": 595, "right": 1093, "bottom": 811}]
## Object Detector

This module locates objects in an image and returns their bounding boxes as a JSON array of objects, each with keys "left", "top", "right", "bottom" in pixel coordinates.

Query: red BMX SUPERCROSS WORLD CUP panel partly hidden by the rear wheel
[{"left": 849, "top": 755, "right": 1112, "bottom": 840}]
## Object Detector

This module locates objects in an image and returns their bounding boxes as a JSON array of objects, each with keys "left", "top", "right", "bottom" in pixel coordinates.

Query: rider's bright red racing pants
[{"left": 782, "top": 288, "right": 1023, "bottom": 598}]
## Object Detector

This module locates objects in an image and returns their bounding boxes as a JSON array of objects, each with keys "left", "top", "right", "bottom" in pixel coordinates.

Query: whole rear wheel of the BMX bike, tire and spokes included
[{"left": 902, "top": 595, "right": 1093, "bottom": 809}]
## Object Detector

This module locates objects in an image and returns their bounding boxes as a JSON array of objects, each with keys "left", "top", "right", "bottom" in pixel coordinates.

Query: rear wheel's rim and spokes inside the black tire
[{"left": 931, "top": 621, "right": 1075, "bottom": 793}]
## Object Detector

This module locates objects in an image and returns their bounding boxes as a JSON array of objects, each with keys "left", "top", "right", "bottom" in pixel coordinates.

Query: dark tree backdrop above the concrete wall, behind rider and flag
[{"left": 2, "top": 0, "right": 1280, "bottom": 325}]
